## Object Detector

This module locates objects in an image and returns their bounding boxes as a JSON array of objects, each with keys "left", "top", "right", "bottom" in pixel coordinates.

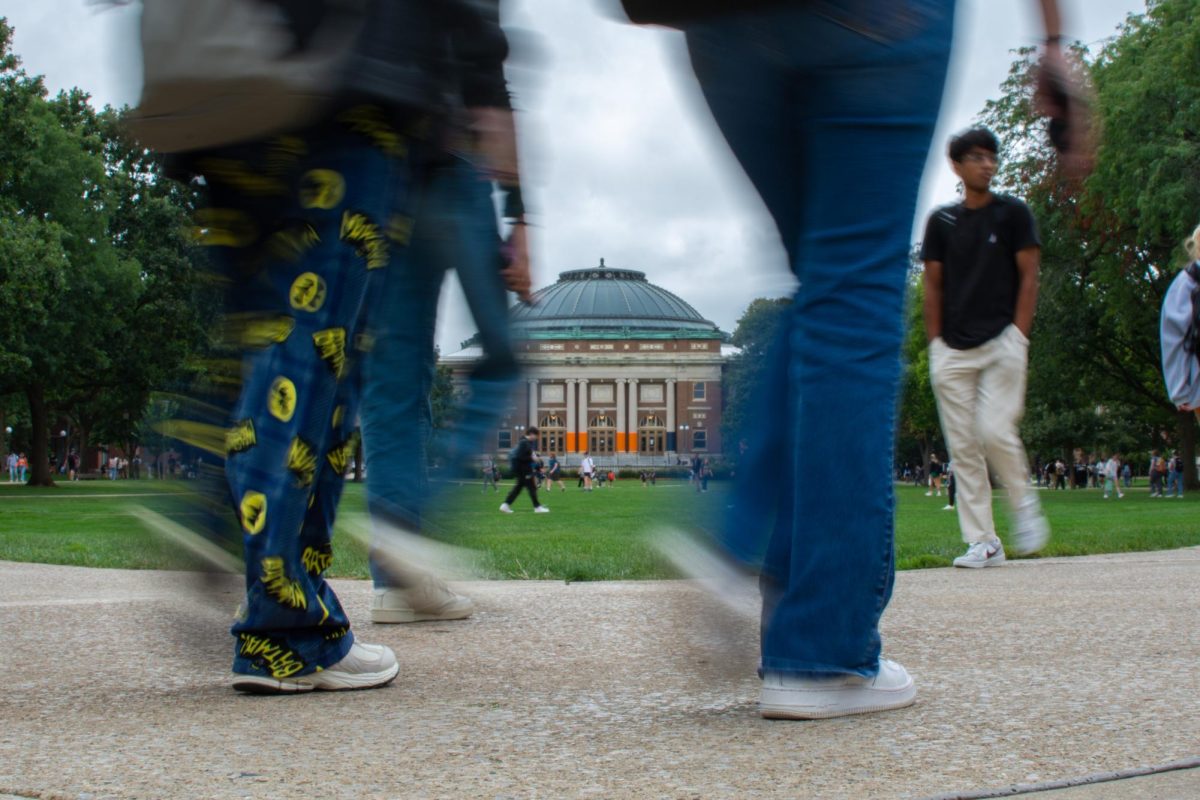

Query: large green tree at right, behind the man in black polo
[{"left": 982, "top": 0, "right": 1200, "bottom": 479}]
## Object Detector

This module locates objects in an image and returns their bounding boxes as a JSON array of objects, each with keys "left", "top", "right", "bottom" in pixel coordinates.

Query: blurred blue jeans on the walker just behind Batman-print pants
[{"left": 361, "top": 158, "right": 518, "bottom": 585}]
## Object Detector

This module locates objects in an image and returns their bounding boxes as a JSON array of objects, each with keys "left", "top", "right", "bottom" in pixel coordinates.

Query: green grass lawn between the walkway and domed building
[{"left": 0, "top": 481, "right": 1200, "bottom": 581}]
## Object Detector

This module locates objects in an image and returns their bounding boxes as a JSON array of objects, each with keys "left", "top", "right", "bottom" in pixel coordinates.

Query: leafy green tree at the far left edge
[{"left": 0, "top": 19, "right": 203, "bottom": 485}]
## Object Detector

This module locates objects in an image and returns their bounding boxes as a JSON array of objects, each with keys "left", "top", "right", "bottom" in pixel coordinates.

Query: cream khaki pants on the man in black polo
[{"left": 929, "top": 325, "right": 1037, "bottom": 543}]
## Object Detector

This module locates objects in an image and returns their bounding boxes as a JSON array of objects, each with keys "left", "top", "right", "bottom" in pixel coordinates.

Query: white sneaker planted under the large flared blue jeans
[{"left": 758, "top": 658, "right": 917, "bottom": 720}]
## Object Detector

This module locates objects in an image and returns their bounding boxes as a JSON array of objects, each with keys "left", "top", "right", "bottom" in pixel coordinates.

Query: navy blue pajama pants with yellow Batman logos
[{"left": 197, "top": 107, "right": 413, "bottom": 679}]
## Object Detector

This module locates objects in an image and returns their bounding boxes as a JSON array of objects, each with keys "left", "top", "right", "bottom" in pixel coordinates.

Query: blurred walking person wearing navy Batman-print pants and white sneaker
[{"left": 143, "top": 0, "right": 520, "bottom": 693}]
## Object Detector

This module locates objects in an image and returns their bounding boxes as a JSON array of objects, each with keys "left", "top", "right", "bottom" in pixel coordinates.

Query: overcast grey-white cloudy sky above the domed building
[{"left": 0, "top": 0, "right": 1145, "bottom": 353}]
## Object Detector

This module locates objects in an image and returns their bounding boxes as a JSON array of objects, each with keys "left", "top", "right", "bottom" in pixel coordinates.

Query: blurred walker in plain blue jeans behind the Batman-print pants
[{"left": 362, "top": 109, "right": 529, "bottom": 622}]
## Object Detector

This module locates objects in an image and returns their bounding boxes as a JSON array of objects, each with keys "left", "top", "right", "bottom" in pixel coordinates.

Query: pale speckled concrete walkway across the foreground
[{"left": 0, "top": 548, "right": 1200, "bottom": 800}]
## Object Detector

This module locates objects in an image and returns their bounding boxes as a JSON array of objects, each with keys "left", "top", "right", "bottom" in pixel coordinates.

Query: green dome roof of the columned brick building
[{"left": 511, "top": 259, "right": 726, "bottom": 339}]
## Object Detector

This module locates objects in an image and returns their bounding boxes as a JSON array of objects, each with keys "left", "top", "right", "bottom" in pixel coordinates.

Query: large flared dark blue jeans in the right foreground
[{"left": 686, "top": 0, "right": 954, "bottom": 675}]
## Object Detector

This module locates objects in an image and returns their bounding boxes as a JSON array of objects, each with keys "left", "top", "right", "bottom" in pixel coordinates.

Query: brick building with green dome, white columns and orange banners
[{"left": 442, "top": 259, "right": 736, "bottom": 465}]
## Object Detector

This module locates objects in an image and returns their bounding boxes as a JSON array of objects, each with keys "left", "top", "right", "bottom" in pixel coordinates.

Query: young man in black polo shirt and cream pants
[{"left": 922, "top": 128, "right": 1050, "bottom": 567}]
